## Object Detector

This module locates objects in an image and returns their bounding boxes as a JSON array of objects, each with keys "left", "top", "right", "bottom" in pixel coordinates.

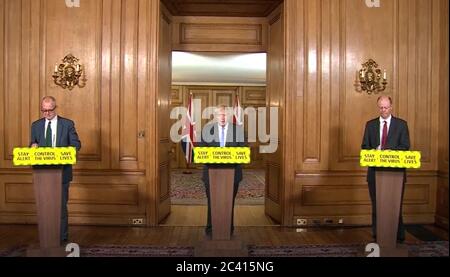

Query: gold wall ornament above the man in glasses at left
[{"left": 52, "top": 54, "right": 87, "bottom": 90}]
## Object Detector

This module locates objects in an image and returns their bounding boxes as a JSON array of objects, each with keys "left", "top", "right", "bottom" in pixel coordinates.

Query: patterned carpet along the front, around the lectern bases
[{"left": 0, "top": 241, "right": 449, "bottom": 257}]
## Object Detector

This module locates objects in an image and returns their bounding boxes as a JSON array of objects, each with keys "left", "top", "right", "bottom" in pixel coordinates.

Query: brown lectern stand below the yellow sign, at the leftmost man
[{"left": 27, "top": 166, "right": 67, "bottom": 257}]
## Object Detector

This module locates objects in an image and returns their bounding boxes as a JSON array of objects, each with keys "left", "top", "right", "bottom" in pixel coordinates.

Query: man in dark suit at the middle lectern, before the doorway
[{"left": 196, "top": 105, "right": 247, "bottom": 235}]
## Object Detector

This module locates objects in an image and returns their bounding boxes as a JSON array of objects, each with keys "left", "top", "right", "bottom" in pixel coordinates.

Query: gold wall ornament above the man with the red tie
[{"left": 355, "top": 59, "right": 387, "bottom": 94}]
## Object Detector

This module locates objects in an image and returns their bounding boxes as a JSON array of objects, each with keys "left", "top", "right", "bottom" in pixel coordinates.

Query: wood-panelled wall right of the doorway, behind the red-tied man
[{"left": 285, "top": 0, "right": 448, "bottom": 225}]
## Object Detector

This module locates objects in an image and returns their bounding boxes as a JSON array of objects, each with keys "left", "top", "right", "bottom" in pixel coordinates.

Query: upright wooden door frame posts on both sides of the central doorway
[{"left": 144, "top": 0, "right": 303, "bottom": 226}]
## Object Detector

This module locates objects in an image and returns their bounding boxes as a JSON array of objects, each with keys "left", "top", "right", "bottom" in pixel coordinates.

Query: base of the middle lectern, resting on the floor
[{"left": 194, "top": 240, "right": 248, "bottom": 257}]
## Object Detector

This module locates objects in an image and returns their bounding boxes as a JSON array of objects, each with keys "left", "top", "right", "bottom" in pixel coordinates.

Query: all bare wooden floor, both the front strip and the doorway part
[{"left": 0, "top": 205, "right": 448, "bottom": 249}]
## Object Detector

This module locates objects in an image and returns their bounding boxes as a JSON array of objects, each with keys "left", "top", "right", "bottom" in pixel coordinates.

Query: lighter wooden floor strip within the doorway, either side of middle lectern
[{"left": 162, "top": 205, "right": 277, "bottom": 226}]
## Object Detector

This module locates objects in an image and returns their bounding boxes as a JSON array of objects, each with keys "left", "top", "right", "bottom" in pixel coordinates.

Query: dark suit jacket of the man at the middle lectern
[{"left": 200, "top": 123, "right": 247, "bottom": 184}]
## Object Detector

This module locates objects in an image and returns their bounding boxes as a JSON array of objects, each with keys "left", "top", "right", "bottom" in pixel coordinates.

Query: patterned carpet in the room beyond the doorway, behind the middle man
[{"left": 170, "top": 170, "right": 265, "bottom": 205}]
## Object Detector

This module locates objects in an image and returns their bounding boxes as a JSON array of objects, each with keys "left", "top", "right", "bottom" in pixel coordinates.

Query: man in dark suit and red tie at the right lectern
[{"left": 361, "top": 96, "right": 410, "bottom": 242}]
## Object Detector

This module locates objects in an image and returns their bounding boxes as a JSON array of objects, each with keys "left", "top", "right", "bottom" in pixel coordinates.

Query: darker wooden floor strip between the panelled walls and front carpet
[{"left": 0, "top": 225, "right": 448, "bottom": 249}]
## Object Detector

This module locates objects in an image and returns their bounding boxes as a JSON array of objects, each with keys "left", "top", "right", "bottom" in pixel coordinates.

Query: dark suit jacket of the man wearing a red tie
[{"left": 361, "top": 116, "right": 410, "bottom": 184}]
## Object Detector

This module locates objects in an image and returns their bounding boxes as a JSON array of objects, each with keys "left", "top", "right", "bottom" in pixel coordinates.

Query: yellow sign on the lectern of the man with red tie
[{"left": 359, "top": 150, "right": 421, "bottom": 168}]
